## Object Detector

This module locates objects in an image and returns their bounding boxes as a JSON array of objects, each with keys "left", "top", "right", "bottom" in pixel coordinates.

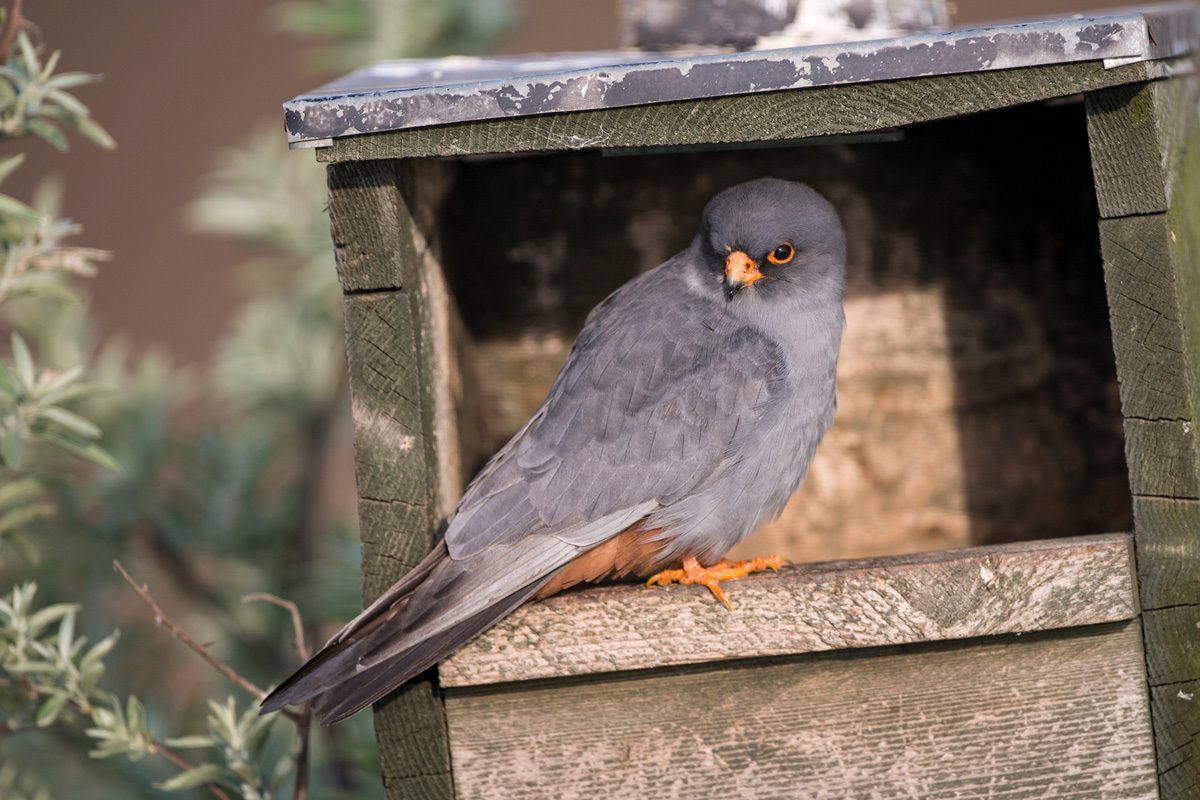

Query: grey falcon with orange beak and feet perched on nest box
[{"left": 262, "top": 178, "right": 846, "bottom": 724}]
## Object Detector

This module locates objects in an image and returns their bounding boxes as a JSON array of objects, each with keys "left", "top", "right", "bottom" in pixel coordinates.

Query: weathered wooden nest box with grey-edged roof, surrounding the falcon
[{"left": 286, "top": 5, "right": 1200, "bottom": 800}]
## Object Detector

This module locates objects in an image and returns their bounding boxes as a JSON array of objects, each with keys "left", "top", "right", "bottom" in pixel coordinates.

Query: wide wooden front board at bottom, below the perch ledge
[{"left": 446, "top": 622, "right": 1157, "bottom": 800}]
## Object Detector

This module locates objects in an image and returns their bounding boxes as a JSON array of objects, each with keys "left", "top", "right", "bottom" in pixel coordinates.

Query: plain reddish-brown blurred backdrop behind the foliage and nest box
[{"left": 10, "top": 0, "right": 1128, "bottom": 363}]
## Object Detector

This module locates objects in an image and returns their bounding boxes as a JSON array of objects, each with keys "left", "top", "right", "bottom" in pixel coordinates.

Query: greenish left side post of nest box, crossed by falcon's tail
[{"left": 330, "top": 163, "right": 455, "bottom": 798}]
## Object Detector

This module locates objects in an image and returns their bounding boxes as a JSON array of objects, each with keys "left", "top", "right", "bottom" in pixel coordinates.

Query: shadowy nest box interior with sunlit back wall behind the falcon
[{"left": 437, "top": 104, "right": 1130, "bottom": 561}]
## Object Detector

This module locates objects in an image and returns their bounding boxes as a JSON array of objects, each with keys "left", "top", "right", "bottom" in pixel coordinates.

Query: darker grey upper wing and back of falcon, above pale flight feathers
[{"left": 446, "top": 263, "right": 786, "bottom": 559}]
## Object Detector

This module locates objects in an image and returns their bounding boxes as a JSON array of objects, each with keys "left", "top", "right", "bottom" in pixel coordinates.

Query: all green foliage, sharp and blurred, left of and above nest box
[{"left": 0, "top": 0, "right": 520, "bottom": 800}]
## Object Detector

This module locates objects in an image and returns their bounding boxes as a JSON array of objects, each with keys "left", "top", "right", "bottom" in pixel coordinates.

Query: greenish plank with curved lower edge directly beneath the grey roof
[{"left": 317, "top": 62, "right": 1152, "bottom": 162}]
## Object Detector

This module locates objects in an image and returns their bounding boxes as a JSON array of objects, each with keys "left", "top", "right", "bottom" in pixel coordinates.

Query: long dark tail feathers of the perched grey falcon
[{"left": 260, "top": 542, "right": 545, "bottom": 724}]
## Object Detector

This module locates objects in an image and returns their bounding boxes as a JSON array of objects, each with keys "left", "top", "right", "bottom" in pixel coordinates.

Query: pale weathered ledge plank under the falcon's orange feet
[{"left": 440, "top": 534, "right": 1136, "bottom": 686}]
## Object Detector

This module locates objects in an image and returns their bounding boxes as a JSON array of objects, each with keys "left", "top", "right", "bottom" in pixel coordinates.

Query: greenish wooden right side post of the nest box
[{"left": 1086, "top": 77, "right": 1200, "bottom": 800}]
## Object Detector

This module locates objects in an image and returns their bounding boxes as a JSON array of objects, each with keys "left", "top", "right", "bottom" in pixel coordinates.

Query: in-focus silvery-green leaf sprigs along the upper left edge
[{"left": 0, "top": 31, "right": 118, "bottom": 563}]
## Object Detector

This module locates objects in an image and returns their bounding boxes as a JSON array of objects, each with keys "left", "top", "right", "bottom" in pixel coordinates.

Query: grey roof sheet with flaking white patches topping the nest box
[{"left": 283, "top": 2, "right": 1200, "bottom": 148}]
